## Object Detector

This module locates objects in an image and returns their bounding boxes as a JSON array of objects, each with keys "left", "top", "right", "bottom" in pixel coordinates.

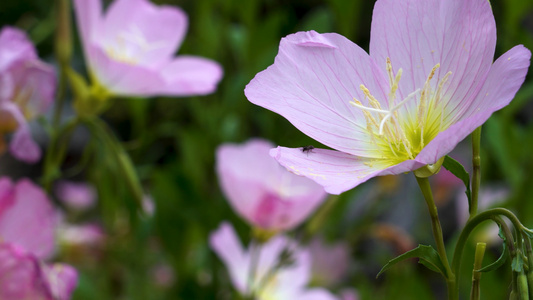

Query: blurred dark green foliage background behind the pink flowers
[{"left": 0, "top": 0, "right": 533, "bottom": 300}]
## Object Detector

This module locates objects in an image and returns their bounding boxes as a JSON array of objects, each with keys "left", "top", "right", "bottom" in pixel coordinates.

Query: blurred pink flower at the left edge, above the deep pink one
[{"left": 0, "top": 27, "right": 56, "bottom": 163}]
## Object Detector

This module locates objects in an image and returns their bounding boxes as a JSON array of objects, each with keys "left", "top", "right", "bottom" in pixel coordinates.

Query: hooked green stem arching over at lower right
[{"left": 452, "top": 208, "right": 525, "bottom": 299}]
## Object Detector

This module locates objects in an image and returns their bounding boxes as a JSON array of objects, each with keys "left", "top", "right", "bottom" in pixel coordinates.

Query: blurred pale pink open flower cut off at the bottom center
[{"left": 209, "top": 223, "right": 336, "bottom": 300}]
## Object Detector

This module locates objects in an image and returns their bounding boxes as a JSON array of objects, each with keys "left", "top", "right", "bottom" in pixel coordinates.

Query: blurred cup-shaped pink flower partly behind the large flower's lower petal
[{"left": 216, "top": 140, "right": 326, "bottom": 230}]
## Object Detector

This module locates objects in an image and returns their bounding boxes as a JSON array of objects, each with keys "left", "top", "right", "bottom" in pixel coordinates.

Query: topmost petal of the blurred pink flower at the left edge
[{"left": 0, "top": 26, "right": 37, "bottom": 73}]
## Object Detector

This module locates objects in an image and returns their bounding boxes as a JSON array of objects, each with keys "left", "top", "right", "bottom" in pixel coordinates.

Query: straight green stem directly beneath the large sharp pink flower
[{"left": 415, "top": 176, "right": 456, "bottom": 299}]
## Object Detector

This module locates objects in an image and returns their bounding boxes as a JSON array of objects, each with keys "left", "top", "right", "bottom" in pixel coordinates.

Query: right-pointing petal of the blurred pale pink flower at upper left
[{"left": 162, "top": 55, "right": 223, "bottom": 96}]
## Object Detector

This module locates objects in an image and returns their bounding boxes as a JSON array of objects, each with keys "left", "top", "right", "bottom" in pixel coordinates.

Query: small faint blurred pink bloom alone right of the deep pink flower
[{"left": 55, "top": 180, "right": 96, "bottom": 210}]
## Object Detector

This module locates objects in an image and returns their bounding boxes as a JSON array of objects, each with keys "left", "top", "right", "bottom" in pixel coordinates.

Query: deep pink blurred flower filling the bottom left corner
[{"left": 0, "top": 177, "right": 77, "bottom": 300}]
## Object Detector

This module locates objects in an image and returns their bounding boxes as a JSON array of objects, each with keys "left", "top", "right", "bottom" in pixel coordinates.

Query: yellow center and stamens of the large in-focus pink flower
[{"left": 350, "top": 58, "right": 452, "bottom": 166}]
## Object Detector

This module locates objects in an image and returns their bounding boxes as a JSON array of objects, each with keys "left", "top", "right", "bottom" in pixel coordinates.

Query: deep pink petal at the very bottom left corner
[{"left": 0, "top": 243, "right": 52, "bottom": 300}]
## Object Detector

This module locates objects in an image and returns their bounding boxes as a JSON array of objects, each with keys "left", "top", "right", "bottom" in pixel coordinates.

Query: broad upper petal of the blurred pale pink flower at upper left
[{"left": 100, "top": 0, "right": 188, "bottom": 67}]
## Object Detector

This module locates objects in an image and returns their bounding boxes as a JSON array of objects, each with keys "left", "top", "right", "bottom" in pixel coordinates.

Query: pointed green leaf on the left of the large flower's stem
[{"left": 376, "top": 245, "right": 447, "bottom": 278}]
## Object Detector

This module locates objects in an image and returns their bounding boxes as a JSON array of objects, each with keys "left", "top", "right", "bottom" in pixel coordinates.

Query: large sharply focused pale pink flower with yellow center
[{"left": 245, "top": 0, "right": 531, "bottom": 194}]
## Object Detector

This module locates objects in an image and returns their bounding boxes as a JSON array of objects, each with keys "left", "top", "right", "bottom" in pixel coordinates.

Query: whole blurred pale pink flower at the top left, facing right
[{"left": 74, "top": 0, "right": 222, "bottom": 96}]
